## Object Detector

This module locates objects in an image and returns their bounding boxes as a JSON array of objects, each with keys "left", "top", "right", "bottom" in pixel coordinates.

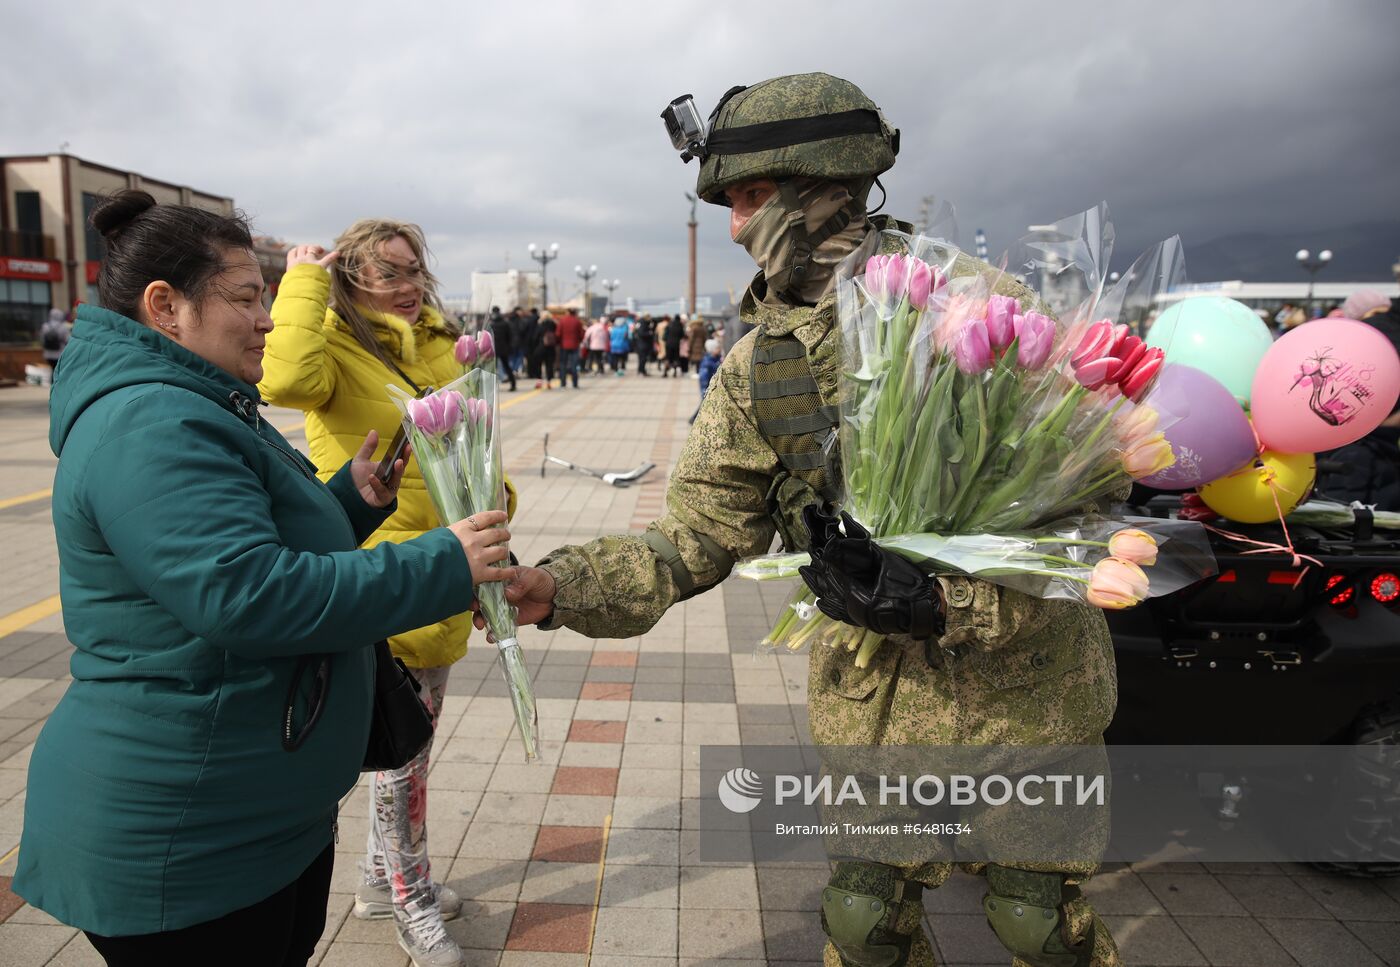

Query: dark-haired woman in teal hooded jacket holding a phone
[{"left": 13, "top": 192, "right": 511, "bottom": 964}]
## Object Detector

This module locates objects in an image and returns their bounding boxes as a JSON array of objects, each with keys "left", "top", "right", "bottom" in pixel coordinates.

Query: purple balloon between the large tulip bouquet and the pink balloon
[{"left": 1142, "top": 362, "right": 1259, "bottom": 490}]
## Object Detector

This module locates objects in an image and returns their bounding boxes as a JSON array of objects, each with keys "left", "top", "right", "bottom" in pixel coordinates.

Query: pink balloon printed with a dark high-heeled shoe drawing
[{"left": 1250, "top": 319, "right": 1400, "bottom": 453}]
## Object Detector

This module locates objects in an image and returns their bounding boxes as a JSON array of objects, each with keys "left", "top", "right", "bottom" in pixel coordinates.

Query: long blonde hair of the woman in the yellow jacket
[{"left": 330, "top": 218, "right": 455, "bottom": 362}]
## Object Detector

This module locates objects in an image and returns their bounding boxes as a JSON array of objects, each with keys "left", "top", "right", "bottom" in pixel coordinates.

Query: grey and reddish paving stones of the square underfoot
[{"left": 0, "top": 374, "right": 1400, "bottom": 967}]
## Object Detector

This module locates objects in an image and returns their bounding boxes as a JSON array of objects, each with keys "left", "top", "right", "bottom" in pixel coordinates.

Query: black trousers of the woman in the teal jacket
[{"left": 87, "top": 844, "right": 336, "bottom": 967}]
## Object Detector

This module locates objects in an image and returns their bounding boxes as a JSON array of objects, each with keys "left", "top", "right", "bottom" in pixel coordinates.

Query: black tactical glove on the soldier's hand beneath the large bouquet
[{"left": 798, "top": 508, "right": 944, "bottom": 638}]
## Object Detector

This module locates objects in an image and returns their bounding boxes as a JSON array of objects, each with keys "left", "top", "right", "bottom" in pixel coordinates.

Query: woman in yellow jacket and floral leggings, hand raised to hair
[{"left": 258, "top": 218, "right": 515, "bottom": 966}]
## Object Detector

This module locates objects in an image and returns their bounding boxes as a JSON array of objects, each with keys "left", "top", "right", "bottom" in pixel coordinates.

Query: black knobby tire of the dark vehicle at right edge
[{"left": 1310, "top": 701, "right": 1400, "bottom": 876}]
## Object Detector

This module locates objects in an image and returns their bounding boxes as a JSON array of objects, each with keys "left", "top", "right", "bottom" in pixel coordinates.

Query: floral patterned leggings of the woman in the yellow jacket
[{"left": 364, "top": 668, "right": 448, "bottom": 946}]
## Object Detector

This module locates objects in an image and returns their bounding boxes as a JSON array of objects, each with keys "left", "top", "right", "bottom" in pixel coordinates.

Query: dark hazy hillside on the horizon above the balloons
[{"left": 1186, "top": 221, "right": 1400, "bottom": 283}]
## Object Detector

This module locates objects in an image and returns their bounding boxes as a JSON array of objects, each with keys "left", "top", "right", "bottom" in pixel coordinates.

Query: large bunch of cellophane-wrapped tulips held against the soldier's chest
[{"left": 736, "top": 207, "right": 1214, "bottom": 666}]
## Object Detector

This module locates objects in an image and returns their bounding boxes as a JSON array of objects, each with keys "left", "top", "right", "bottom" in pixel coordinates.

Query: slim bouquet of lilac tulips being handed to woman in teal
[{"left": 389, "top": 366, "right": 539, "bottom": 760}]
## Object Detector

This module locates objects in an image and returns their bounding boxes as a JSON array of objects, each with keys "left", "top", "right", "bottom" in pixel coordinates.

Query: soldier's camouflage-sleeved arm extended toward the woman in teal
[{"left": 540, "top": 340, "right": 778, "bottom": 638}]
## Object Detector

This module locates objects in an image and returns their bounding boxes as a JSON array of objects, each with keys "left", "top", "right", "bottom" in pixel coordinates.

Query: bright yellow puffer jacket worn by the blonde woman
[{"left": 258, "top": 264, "right": 515, "bottom": 668}]
